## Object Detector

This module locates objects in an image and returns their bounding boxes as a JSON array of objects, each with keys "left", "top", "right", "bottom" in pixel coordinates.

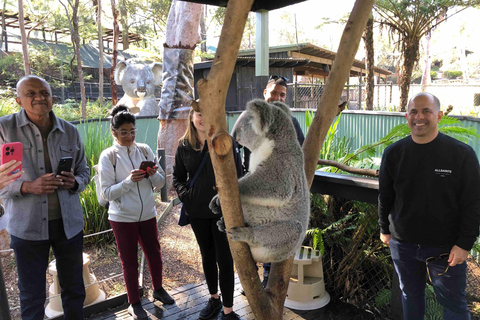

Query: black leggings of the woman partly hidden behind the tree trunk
[{"left": 189, "top": 215, "right": 235, "bottom": 308}]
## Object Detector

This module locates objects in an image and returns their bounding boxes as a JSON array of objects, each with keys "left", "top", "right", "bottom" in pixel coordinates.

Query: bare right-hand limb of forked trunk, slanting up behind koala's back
[{"left": 303, "top": 0, "right": 374, "bottom": 187}]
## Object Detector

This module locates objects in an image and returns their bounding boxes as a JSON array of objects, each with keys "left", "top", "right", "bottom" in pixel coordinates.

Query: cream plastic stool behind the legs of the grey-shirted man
[{"left": 45, "top": 253, "right": 105, "bottom": 318}]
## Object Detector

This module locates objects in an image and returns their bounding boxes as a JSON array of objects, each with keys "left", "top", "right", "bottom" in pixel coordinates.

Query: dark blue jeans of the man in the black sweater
[{"left": 390, "top": 238, "right": 470, "bottom": 320}]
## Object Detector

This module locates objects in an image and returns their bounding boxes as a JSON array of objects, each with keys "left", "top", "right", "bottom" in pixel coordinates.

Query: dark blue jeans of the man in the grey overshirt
[{"left": 10, "top": 219, "right": 85, "bottom": 320}]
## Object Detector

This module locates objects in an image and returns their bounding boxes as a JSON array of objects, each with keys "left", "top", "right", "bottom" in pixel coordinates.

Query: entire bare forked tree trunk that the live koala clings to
[{"left": 197, "top": 0, "right": 373, "bottom": 320}]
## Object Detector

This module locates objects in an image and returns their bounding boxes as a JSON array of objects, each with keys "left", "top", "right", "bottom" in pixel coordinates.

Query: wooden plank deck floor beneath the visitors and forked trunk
[{"left": 88, "top": 277, "right": 375, "bottom": 320}]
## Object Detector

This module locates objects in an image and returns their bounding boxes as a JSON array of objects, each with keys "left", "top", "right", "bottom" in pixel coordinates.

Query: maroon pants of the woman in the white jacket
[{"left": 110, "top": 218, "right": 162, "bottom": 304}]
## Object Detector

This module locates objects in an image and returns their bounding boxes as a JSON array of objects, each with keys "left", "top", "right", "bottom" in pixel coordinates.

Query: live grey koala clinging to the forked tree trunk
[{"left": 210, "top": 100, "right": 310, "bottom": 262}]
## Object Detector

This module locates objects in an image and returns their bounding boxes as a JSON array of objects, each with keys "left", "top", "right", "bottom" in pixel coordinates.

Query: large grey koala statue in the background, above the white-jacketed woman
[{"left": 115, "top": 61, "right": 162, "bottom": 116}]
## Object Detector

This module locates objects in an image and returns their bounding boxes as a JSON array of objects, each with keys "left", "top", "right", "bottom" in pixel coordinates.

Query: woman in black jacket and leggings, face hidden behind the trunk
[{"left": 173, "top": 108, "right": 243, "bottom": 319}]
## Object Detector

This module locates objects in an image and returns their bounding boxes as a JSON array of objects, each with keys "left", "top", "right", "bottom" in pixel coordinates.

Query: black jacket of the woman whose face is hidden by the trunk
[{"left": 173, "top": 141, "right": 242, "bottom": 219}]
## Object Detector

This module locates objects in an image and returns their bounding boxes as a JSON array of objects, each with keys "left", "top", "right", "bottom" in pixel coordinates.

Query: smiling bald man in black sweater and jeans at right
[{"left": 378, "top": 93, "right": 480, "bottom": 320}]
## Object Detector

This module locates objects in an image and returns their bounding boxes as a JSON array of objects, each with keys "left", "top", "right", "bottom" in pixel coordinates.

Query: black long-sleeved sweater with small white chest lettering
[{"left": 378, "top": 133, "right": 480, "bottom": 250}]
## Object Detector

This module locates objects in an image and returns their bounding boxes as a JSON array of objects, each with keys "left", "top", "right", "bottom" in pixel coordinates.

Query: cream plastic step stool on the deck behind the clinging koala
[{"left": 285, "top": 246, "right": 330, "bottom": 310}]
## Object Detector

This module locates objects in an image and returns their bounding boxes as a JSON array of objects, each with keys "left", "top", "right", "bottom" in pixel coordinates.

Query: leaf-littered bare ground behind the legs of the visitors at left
[{"left": 1, "top": 193, "right": 204, "bottom": 320}]
